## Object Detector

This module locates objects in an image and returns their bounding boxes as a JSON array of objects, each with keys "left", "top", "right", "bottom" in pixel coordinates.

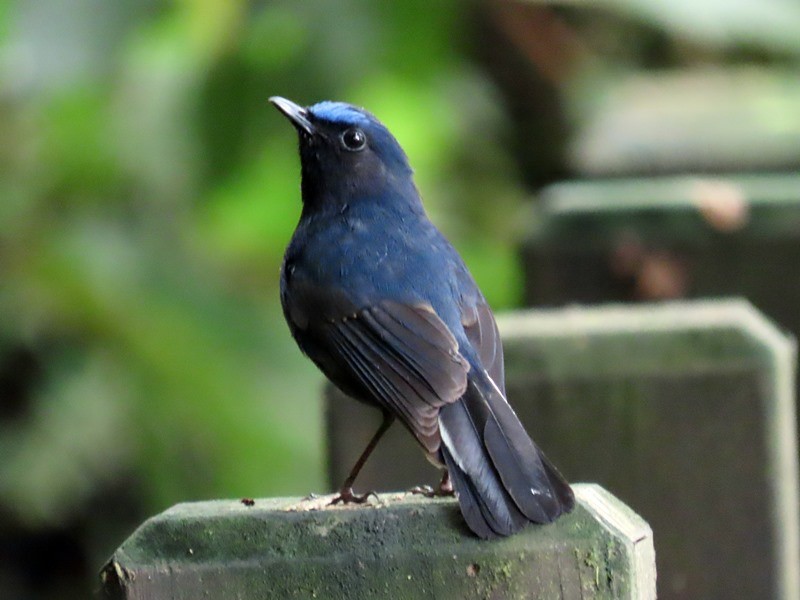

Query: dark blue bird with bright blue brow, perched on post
[{"left": 269, "top": 96, "right": 575, "bottom": 539}]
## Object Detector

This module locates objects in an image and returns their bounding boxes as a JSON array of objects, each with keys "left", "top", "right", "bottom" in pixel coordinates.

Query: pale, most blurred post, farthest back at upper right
[{"left": 564, "top": 69, "right": 800, "bottom": 178}]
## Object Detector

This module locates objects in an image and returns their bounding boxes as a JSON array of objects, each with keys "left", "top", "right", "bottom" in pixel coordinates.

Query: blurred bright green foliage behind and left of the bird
[{"left": 0, "top": 0, "right": 522, "bottom": 540}]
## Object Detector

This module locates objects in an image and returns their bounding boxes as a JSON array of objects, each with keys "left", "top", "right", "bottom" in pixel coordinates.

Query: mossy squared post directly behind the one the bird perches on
[{"left": 328, "top": 301, "right": 800, "bottom": 600}]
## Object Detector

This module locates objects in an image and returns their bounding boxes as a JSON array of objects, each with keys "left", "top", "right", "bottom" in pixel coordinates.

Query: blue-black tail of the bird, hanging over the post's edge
[{"left": 439, "top": 369, "right": 575, "bottom": 538}]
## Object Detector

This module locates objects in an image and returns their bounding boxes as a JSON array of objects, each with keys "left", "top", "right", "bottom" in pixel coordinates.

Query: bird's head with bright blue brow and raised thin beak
[{"left": 270, "top": 96, "right": 413, "bottom": 210}]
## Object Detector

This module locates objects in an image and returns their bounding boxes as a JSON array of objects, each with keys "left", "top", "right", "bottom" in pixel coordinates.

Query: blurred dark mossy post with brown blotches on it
[{"left": 523, "top": 174, "right": 800, "bottom": 336}]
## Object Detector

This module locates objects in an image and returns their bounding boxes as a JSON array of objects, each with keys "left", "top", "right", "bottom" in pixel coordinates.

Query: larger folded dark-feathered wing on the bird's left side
[{"left": 325, "top": 301, "right": 469, "bottom": 453}]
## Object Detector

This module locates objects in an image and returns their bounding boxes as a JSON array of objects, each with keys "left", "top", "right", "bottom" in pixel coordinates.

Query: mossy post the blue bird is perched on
[{"left": 101, "top": 484, "right": 655, "bottom": 600}]
